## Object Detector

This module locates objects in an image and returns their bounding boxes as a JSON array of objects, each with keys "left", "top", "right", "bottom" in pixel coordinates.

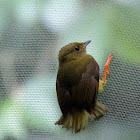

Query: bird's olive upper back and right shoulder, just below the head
[{"left": 57, "top": 54, "right": 98, "bottom": 88}]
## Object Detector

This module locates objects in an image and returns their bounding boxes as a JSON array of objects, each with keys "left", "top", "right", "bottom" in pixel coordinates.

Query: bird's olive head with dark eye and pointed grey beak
[{"left": 59, "top": 40, "right": 91, "bottom": 63}]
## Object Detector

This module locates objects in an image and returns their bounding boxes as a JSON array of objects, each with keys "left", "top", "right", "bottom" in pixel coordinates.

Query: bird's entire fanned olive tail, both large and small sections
[{"left": 55, "top": 101, "right": 107, "bottom": 133}]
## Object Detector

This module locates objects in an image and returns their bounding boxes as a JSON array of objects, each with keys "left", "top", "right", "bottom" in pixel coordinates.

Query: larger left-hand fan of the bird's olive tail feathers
[{"left": 55, "top": 109, "right": 89, "bottom": 133}]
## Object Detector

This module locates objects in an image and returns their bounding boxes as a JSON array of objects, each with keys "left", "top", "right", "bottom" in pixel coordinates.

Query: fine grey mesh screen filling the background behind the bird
[{"left": 0, "top": 0, "right": 140, "bottom": 140}]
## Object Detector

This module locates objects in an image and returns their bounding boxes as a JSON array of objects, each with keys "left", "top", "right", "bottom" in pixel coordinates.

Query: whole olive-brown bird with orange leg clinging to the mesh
[{"left": 55, "top": 40, "right": 112, "bottom": 133}]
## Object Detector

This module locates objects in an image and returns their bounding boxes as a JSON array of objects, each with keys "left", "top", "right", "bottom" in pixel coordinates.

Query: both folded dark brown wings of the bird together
[{"left": 56, "top": 58, "right": 99, "bottom": 114}]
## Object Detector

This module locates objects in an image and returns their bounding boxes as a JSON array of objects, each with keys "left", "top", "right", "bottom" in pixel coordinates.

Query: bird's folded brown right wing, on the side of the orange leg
[{"left": 71, "top": 58, "right": 99, "bottom": 112}]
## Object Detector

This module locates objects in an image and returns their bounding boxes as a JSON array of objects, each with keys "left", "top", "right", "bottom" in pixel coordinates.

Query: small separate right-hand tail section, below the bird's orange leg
[{"left": 90, "top": 101, "right": 108, "bottom": 120}]
